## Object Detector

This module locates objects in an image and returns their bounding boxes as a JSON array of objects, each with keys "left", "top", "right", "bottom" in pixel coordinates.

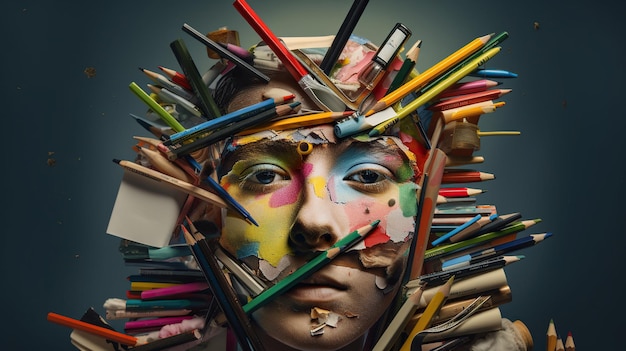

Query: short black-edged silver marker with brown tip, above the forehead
[{"left": 358, "top": 23, "right": 411, "bottom": 90}]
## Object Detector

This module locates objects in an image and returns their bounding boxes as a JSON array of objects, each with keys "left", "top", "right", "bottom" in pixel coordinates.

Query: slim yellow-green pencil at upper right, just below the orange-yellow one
[{"left": 369, "top": 47, "right": 500, "bottom": 136}]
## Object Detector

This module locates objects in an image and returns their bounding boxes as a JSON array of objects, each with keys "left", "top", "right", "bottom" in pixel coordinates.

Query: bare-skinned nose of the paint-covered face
[{"left": 289, "top": 179, "right": 347, "bottom": 252}]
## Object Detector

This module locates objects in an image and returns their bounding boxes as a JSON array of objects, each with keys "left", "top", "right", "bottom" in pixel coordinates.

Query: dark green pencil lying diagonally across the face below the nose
[{"left": 243, "top": 220, "right": 380, "bottom": 314}]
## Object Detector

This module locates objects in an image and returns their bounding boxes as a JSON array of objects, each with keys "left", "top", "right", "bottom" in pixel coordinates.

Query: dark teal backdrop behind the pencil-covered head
[{"left": 0, "top": 0, "right": 626, "bottom": 350}]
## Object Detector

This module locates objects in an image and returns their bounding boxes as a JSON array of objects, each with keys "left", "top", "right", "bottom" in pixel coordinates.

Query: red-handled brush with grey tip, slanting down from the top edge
[{"left": 233, "top": 0, "right": 346, "bottom": 111}]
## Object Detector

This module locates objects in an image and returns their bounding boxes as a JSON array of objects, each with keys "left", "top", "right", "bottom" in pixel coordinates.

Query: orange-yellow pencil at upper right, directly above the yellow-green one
[{"left": 365, "top": 34, "right": 492, "bottom": 116}]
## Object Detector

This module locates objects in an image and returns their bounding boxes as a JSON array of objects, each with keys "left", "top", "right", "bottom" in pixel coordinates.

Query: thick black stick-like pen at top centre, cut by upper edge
[{"left": 320, "top": 0, "right": 369, "bottom": 76}]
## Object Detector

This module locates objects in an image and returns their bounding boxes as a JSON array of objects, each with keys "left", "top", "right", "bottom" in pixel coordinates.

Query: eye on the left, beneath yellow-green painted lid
[{"left": 239, "top": 164, "right": 291, "bottom": 193}]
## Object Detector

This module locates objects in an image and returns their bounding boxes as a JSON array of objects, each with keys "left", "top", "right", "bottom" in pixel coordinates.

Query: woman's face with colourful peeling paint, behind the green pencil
[{"left": 220, "top": 126, "right": 417, "bottom": 350}]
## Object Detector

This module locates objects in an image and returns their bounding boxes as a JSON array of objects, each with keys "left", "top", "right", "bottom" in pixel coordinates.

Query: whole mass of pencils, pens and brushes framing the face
[{"left": 49, "top": 0, "right": 552, "bottom": 351}]
